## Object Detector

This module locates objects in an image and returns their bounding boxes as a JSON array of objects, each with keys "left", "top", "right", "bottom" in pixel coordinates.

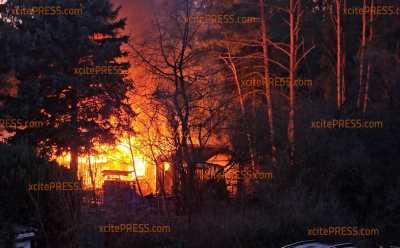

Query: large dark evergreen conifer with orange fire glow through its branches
[{"left": 2, "top": 0, "right": 131, "bottom": 180}]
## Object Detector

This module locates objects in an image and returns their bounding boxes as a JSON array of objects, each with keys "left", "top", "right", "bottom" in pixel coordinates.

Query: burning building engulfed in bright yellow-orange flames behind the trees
[{"left": 57, "top": 141, "right": 236, "bottom": 203}]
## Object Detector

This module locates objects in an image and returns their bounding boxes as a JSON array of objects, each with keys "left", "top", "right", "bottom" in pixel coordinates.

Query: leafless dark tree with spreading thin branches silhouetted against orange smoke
[{"left": 130, "top": 0, "right": 227, "bottom": 220}]
